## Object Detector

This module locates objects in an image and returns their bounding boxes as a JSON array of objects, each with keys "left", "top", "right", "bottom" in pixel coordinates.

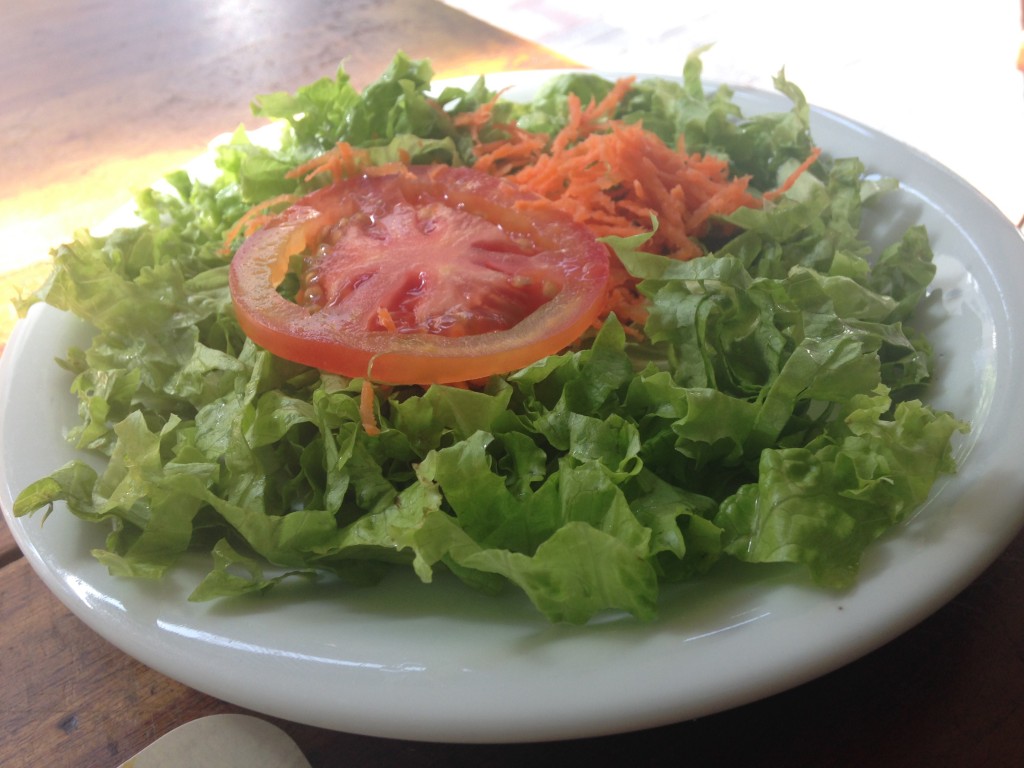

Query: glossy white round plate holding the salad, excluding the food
[{"left": 6, "top": 73, "right": 1024, "bottom": 742}]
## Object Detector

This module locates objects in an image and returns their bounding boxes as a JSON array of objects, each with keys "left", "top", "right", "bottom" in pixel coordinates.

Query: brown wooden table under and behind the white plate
[{"left": 0, "top": 0, "right": 1024, "bottom": 768}]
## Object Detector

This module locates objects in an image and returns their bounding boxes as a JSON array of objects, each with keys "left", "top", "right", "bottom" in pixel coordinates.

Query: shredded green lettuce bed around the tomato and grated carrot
[{"left": 14, "top": 53, "right": 968, "bottom": 624}]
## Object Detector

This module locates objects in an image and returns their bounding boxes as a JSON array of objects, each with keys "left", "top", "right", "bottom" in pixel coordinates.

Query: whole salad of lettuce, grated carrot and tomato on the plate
[{"left": 13, "top": 54, "right": 968, "bottom": 624}]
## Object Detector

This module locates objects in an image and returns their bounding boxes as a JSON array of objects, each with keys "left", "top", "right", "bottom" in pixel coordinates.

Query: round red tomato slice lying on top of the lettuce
[{"left": 230, "top": 165, "right": 608, "bottom": 384}]
